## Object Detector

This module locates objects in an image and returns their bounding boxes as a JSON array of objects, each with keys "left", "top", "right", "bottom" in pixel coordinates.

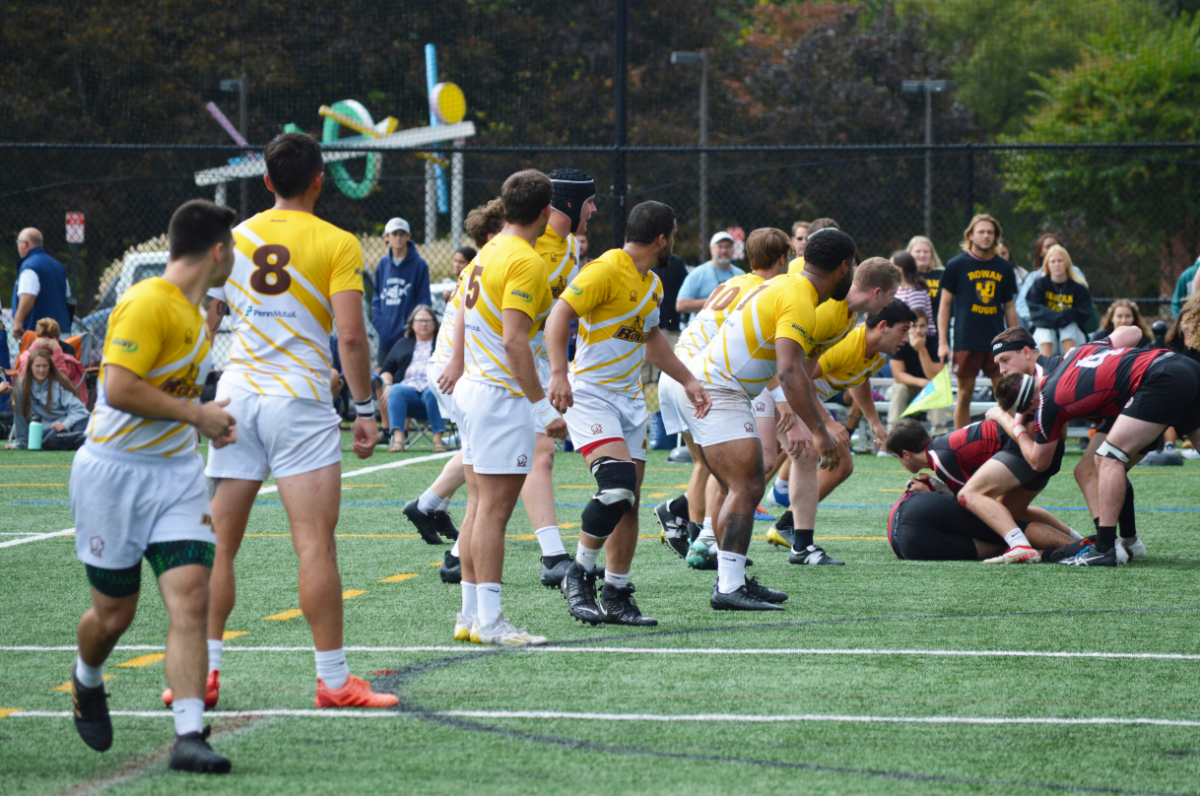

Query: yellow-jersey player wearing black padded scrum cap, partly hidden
[{"left": 521, "top": 168, "right": 596, "bottom": 588}]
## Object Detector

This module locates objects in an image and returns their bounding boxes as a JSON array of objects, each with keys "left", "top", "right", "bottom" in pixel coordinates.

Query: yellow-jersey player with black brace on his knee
[{"left": 546, "top": 202, "right": 710, "bottom": 626}]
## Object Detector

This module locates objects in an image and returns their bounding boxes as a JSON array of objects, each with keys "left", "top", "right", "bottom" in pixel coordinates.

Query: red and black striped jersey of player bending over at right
[{"left": 1034, "top": 340, "right": 1175, "bottom": 444}]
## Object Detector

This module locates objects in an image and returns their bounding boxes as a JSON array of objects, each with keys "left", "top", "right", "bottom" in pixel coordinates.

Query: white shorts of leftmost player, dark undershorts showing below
[{"left": 71, "top": 444, "right": 217, "bottom": 569}]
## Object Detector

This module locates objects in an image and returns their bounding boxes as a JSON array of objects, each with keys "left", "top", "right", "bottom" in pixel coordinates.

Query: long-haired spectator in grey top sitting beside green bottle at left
[{"left": 8, "top": 348, "right": 90, "bottom": 450}]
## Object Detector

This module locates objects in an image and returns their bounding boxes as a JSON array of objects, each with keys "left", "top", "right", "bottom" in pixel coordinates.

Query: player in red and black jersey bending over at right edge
[{"left": 996, "top": 328, "right": 1200, "bottom": 567}]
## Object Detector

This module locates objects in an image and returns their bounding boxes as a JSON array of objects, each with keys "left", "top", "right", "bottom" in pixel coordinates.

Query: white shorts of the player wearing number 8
[{"left": 204, "top": 377, "right": 342, "bottom": 481}]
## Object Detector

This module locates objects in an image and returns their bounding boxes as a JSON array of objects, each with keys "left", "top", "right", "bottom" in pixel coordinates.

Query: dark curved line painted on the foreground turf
[{"left": 374, "top": 606, "right": 1200, "bottom": 796}]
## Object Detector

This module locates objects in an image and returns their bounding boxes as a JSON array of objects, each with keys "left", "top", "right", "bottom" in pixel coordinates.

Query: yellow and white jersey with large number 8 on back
[{"left": 209, "top": 210, "right": 362, "bottom": 403}]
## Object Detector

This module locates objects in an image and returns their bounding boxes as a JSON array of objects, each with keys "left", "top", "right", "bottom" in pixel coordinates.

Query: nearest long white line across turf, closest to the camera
[{"left": 7, "top": 708, "right": 1200, "bottom": 728}]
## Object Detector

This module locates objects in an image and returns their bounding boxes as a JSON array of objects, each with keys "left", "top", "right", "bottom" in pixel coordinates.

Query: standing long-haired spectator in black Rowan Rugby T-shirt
[{"left": 937, "top": 213, "right": 1016, "bottom": 429}]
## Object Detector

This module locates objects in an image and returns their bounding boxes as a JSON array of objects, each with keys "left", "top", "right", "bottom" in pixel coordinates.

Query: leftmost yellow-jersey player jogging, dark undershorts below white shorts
[{"left": 71, "top": 199, "right": 238, "bottom": 773}]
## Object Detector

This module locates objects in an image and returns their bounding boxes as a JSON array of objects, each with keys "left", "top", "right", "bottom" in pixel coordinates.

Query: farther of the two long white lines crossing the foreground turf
[{"left": 7, "top": 644, "right": 1200, "bottom": 660}]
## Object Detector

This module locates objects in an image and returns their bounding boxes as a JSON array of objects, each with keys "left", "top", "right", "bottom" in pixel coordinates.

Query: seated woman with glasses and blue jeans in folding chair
[{"left": 379, "top": 304, "right": 446, "bottom": 453}]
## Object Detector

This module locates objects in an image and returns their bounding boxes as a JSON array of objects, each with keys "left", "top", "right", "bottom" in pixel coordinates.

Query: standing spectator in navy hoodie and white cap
[{"left": 371, "top": 219, "right": 433, "bottom": 365}]
